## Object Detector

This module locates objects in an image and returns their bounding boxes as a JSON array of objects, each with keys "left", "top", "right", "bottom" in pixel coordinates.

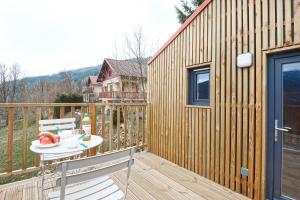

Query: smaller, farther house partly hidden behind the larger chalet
[{"left": 82, "top": 76, "right": 102, "bottom": 102}]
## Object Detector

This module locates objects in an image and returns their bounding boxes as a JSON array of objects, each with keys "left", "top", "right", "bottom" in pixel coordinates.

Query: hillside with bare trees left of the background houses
[{"left": 0, "top": 64, "right": 100, "bottom": 103}]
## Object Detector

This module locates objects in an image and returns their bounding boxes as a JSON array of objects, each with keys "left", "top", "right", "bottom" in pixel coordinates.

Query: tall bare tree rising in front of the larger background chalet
[{"left": 125, "top": 26, "right": 147, "bottom": 101}]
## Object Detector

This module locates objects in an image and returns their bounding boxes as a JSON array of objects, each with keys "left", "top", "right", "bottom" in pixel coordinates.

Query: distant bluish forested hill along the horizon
[{"left": 26, "top": 65, "right": 100, "bottom": 85}]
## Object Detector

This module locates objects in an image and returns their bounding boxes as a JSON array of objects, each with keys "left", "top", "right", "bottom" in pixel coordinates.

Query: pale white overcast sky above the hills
[{"left": 0, "top": 0, "right": 180, "bottom": 76}]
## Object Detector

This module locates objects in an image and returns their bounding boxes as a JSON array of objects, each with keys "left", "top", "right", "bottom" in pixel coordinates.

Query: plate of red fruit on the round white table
[{"left": 32, "top": 132, "right": 60, "bottom": 148}]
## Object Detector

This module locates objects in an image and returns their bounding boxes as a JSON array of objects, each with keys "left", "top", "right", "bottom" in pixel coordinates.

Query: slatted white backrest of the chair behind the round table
[{"left": 39, "top": 118, "right": 76, "bottom": 131}]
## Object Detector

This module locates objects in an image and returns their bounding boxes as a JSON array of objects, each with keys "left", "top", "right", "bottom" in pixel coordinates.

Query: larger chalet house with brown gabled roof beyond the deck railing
[{"left": 97, "top": 59, "right": 147, "bottom": 102}]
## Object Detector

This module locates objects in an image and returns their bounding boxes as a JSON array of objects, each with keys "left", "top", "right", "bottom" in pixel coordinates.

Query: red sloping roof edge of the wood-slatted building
[{"left": 148, "top": 0, "right": 212, "bottom": 65}]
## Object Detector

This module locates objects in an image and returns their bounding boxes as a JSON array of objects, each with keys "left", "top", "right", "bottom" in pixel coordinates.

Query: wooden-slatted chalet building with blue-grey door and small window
[{"left": 147, "top": 0, "right": 300, "bottom": 199}]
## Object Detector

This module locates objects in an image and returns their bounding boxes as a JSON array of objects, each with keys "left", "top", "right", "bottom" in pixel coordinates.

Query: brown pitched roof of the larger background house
[{"left": 102, "top": 58, "right": 149, "bottom": 77}]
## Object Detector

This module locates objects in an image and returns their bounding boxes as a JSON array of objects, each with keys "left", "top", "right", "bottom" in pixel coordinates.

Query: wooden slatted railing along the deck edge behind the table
[{"left": 0, "top": 103, "right": 147, "bottom": 178}]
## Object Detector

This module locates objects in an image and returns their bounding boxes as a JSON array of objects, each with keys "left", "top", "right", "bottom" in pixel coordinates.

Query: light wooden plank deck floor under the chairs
[{"left": 0, "top": 152, "right": 248, "bottom": 200}]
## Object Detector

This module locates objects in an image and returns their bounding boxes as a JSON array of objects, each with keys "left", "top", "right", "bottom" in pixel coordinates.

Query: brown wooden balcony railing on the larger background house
[{"left": 99, "top": 92, "right": 146, "bottom": 99}]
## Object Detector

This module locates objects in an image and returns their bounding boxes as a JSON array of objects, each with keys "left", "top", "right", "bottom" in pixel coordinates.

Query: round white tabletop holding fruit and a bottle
[{"left": 30, "top": 135, "right": 103, "bottom": 154}]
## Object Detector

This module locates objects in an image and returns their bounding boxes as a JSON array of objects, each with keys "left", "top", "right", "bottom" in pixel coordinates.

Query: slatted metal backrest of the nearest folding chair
[{"left": 56, "top": 147, "right": 135, "bottom": 199}]
